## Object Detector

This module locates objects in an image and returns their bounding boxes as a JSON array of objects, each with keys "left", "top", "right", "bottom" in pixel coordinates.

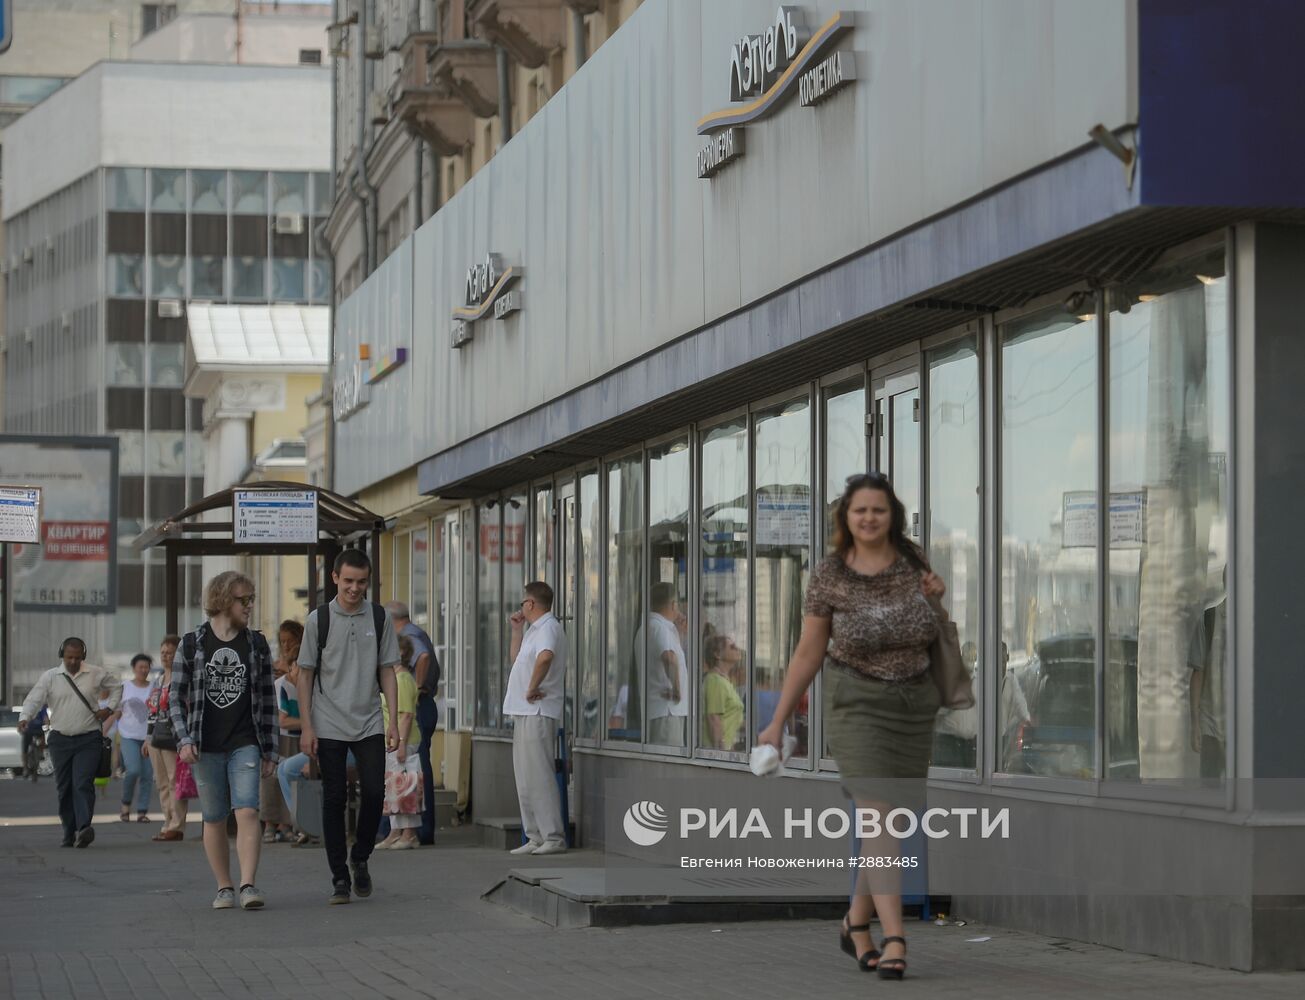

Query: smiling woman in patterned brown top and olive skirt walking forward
[{"left": 758, "top": 473, "right": 946, "bottom": 979}]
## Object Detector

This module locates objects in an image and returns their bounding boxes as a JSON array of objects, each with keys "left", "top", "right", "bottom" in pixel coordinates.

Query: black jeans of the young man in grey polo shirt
[{"left": 317, "top": 734, "right": 385, "bottom": 881}]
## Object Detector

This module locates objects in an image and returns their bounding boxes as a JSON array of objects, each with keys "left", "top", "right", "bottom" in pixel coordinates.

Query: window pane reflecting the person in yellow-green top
[{"left": 698, "top": 416, "right": 748, "bottom": 751}]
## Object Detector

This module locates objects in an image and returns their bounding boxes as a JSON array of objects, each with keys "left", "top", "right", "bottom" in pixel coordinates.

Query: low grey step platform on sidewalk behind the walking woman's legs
[{"left": 482, "top": 868, "right": 847, "bottom": 928}]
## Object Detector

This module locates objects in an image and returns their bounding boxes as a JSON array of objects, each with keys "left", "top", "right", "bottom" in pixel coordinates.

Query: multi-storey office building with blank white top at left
[{"left": 4, "top": 63, "right": 330, "bottom": 692}]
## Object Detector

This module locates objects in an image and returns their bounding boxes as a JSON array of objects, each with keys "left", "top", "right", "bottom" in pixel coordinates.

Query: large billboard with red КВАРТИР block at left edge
[{"left": 0, "top": 435, "right": 117, "bottom": 614}]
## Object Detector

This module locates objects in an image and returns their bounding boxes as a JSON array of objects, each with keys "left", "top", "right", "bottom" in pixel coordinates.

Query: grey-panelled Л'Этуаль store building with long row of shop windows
[{"left": 333, "top": 0, "right": 1305, "bottom": 969}]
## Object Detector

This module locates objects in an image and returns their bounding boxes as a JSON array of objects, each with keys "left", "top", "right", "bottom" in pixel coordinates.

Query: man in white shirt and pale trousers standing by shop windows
[{"left": 502, "top": 581, "right": 566, "bottom": 854}]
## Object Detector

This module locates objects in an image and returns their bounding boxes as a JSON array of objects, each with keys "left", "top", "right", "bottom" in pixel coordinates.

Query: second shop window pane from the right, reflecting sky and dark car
[{"left": 996, "top": 305, "right": 1099, "bottom": 778}]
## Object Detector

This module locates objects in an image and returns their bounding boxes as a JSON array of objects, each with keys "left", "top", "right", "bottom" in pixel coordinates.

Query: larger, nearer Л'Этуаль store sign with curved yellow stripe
[{"left": 697, "top": 5, "right": 856, "bottom": 178}]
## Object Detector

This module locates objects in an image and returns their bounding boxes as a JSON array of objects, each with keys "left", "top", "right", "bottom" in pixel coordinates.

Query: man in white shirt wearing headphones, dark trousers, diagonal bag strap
[{"left": 18, "top": 636, "right": 123, "bottom": 847}]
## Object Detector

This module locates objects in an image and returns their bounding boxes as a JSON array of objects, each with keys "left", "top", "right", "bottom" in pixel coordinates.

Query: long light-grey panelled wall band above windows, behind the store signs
[{"left": 337, "top": 0, "right": 1135, "bottom": 491}]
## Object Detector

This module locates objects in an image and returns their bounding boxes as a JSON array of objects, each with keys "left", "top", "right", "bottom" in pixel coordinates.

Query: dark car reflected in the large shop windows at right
[{"left": 1017, "top": 634, "right": 1138, "bottom": 778}]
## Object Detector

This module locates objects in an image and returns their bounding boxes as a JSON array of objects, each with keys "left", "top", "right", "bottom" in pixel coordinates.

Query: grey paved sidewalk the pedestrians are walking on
[{"left": 0, "top": 781, "right": 1305, "bottom": 1000}]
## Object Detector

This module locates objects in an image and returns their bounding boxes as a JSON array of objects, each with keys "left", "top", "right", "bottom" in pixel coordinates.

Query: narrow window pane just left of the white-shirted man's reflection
[{"left": 606, "top": 454, "right": 643, "bottom": 743}]
